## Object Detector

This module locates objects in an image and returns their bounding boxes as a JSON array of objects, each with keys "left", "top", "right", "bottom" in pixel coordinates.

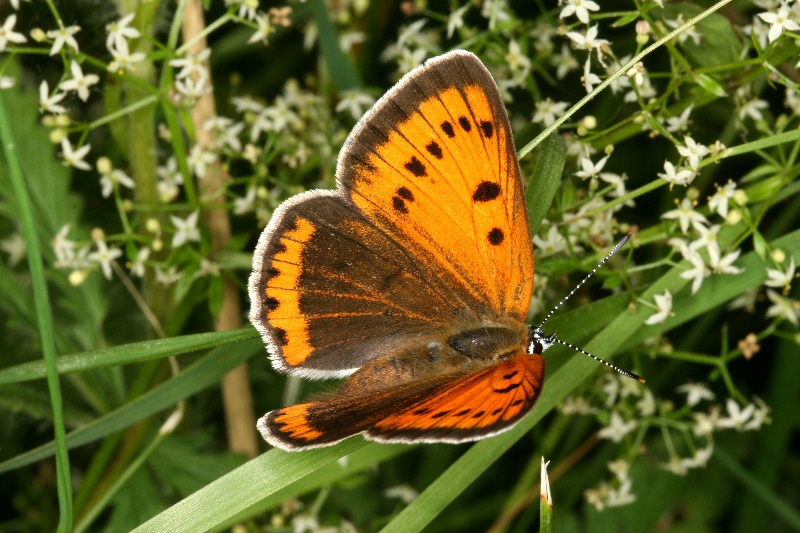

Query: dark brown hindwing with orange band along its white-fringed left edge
[{"left": 250, "top": 192, "right": 478, "bottom": 377}]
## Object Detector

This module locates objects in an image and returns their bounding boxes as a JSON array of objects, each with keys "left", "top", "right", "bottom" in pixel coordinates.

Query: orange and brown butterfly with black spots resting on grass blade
[{"left": 249, "top": 51, "right": 632, "bottom": 451}]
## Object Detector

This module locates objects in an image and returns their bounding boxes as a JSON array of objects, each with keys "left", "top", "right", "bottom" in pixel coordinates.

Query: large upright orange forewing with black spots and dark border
[{"left": 338, "top": 52, "right": 533, "bottom": 320}]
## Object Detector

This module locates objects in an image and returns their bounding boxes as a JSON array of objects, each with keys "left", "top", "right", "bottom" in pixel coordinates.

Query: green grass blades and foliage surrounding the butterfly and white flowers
[{"left": 0, "top": 0, "right": 800, "bottom": 531}]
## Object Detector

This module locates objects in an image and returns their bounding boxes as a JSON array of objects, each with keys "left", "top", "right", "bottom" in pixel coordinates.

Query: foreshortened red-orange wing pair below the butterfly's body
[{"left": 258, "top": 352, "right": 544, "bottom": 449}]
